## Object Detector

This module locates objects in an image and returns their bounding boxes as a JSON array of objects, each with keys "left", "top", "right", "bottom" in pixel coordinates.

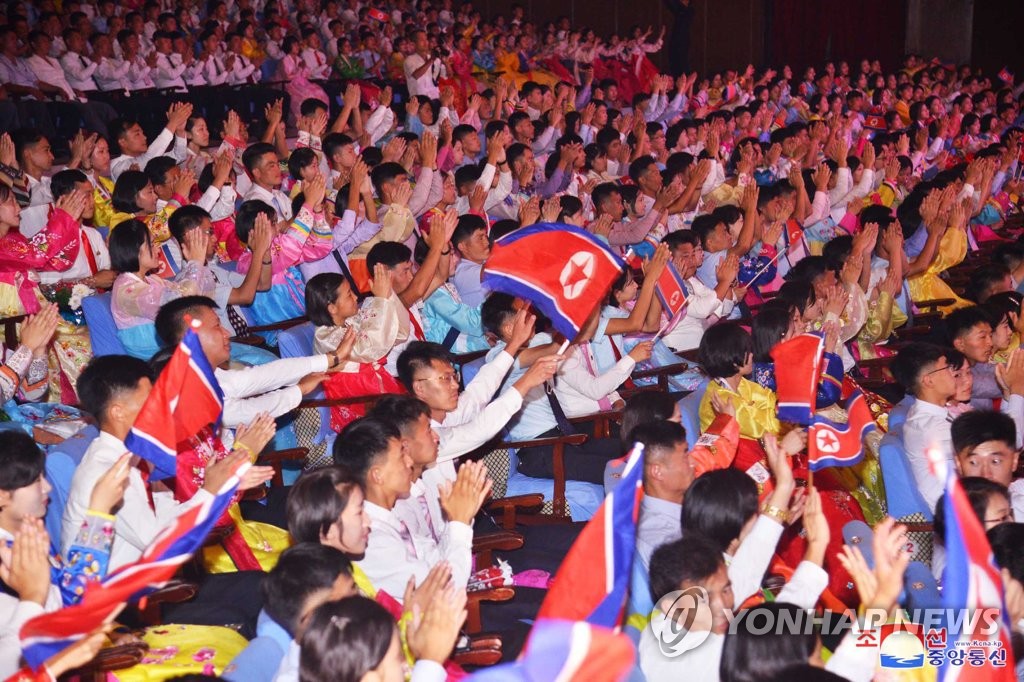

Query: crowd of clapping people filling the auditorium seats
[{"left": 0, "top": 0, "right": 1024, "bottom": 682}]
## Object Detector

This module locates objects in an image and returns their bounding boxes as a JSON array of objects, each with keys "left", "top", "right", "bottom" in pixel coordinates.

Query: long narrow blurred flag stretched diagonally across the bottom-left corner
[{"left": 19, "top": 462, "right": 245, "bottom": 670}]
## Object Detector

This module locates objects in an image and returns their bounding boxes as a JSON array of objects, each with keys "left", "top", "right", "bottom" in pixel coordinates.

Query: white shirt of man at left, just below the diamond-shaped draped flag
[{"left": 60, "top": 431, "right": 210, "bottom": 571}]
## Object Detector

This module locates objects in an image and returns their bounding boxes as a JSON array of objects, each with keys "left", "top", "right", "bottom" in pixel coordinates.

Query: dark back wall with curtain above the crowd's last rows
[{"left": 474, "top": 0, "right": 1024, "bottom": 81}]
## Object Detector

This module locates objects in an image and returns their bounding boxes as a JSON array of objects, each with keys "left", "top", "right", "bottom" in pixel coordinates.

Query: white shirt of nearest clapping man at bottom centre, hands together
[{"left": 356, "top": 502, "right": 473, "bottom": 601}]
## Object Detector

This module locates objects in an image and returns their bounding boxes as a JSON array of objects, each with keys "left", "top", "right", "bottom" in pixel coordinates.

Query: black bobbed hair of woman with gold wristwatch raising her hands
[{"left": 682, "top": 469, "right": 758, "bottom": 552}]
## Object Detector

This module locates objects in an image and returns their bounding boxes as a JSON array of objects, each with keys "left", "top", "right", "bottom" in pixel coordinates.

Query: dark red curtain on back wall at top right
[{"left": 768, "top": 0, "right": 906, "bottom": 71}]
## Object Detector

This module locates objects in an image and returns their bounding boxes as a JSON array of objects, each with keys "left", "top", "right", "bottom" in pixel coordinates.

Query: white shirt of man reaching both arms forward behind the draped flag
[{"left": 213, "top": 355, "right": 328, "bottom": 428}]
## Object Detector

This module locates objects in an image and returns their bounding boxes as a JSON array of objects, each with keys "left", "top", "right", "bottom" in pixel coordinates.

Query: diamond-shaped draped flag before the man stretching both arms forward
[{"left": 125, "top": 323, "right": 224, "bottom": 480}]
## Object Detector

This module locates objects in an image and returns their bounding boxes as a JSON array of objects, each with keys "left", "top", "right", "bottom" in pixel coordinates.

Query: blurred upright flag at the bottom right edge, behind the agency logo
[{"left": 928, "top": 449, "right": 1017, "bottom": 682}]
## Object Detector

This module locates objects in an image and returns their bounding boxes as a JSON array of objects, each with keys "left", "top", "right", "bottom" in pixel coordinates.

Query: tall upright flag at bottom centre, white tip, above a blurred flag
[{"left": 530, "top": 443, "right": 643, "bottom": 626}]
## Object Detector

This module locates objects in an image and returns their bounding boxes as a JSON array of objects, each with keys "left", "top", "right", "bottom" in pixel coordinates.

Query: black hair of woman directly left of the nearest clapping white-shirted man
[{"left": 286, "top": 466, "right": 361, "bottom": 543}]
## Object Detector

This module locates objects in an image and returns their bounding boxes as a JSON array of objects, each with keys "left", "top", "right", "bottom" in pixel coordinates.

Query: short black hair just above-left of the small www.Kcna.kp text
[{"left": 260, "top": 543, "right": 352, "bottom": 637}]
